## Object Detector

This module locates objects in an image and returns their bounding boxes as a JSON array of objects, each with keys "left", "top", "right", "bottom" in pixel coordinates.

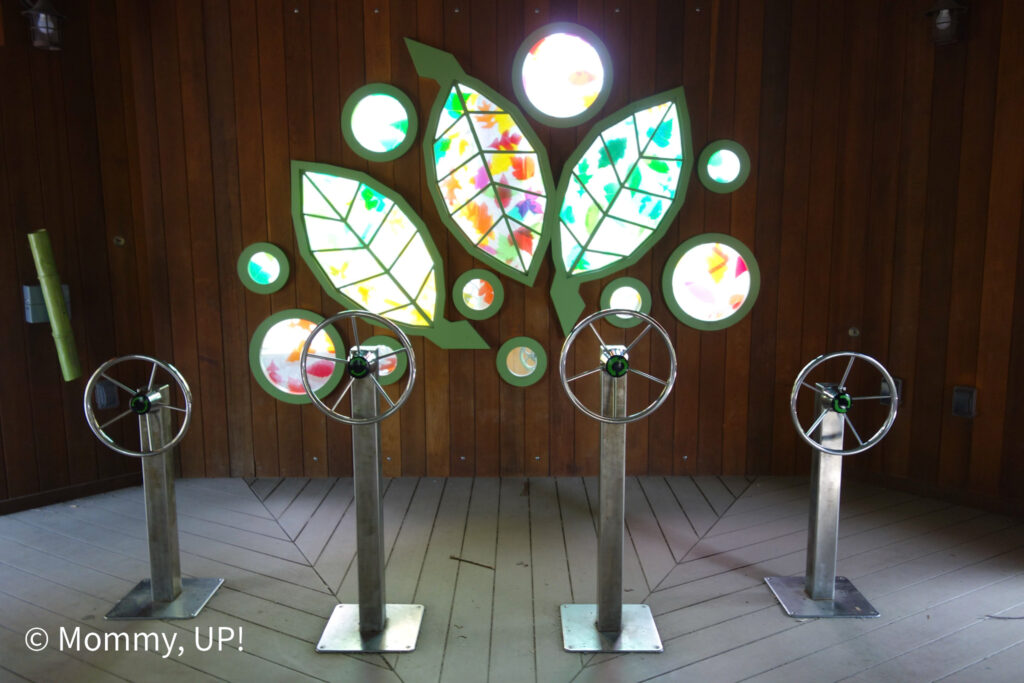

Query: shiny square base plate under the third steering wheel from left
[{"left": 561, "top": 604, "right": 665, "bottom": 652}]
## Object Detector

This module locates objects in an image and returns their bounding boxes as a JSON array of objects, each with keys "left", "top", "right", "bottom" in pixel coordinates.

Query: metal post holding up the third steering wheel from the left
[{"left": 597, "top": 373, "right": 627, "bottom": 633}]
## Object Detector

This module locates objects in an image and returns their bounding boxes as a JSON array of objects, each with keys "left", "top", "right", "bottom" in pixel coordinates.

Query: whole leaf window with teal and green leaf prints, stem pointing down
[{"left": 546, "top": 87, "right": 693, "bottom": 334}]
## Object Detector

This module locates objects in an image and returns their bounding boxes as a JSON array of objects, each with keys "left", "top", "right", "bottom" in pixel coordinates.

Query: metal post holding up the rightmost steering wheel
[{"left": 805, "top": 385, "right": 844, "bottom": 600}]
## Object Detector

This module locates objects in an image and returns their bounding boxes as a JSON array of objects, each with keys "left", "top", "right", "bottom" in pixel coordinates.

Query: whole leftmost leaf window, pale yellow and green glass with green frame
[{"left": 292, "top": 161, "right": 487, "bottom": 348}]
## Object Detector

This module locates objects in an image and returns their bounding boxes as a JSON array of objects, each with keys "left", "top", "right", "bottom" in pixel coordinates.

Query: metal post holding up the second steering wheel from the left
[{"left": 352, "top": 370, "right": 386, "bottom": 634}]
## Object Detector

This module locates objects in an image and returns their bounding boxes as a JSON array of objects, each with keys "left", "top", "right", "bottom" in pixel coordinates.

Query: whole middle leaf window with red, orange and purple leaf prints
[{"left": 406, "top": 38, "right": 554, "bottom": 285}]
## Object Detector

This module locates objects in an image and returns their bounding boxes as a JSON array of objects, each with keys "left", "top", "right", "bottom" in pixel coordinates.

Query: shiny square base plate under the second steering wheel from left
[{"left": 316, "top": 604, "right": 423, "bottom": 652}]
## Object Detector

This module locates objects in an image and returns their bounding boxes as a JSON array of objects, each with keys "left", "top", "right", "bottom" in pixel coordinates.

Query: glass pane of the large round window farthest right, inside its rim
[{"left": 672, "top": 243, "right": 751, "bottom": 323}]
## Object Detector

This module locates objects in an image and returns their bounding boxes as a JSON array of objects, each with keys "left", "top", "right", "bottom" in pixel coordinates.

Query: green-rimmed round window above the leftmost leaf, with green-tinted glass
[{"left": 341, "top": 83, "right": 417, "bottom": 161}]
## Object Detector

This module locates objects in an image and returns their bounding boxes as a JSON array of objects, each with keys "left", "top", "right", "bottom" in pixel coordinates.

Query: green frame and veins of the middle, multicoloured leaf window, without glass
[{"left": 406, "top": 38, "right": 554, "bottom": 286}]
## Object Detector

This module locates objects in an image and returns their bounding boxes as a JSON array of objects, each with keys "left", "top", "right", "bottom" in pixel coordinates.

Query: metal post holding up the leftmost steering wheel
[{"left": 138, "top": 385, "right": 181, "bottom": 602}]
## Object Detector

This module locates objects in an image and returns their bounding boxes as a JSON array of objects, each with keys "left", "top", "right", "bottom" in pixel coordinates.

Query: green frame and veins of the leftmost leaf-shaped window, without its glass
[{"left": 292, "top": 160, "right": 488, "bottom": 348}]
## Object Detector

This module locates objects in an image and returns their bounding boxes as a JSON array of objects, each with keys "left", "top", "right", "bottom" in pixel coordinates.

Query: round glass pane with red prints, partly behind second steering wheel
[{"left": 259, "top": 317, "right": 335, "bottom": 394}]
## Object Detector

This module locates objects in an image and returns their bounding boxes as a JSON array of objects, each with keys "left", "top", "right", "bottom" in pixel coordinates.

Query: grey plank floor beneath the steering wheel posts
[{"left": 0, "top": 477, "right": 1024, "bottom": 683}]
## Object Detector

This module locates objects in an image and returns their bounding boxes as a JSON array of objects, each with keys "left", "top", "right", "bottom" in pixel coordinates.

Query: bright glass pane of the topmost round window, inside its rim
[{"left": 522, "top": 33, "right": 604, "bottom": 119}]
